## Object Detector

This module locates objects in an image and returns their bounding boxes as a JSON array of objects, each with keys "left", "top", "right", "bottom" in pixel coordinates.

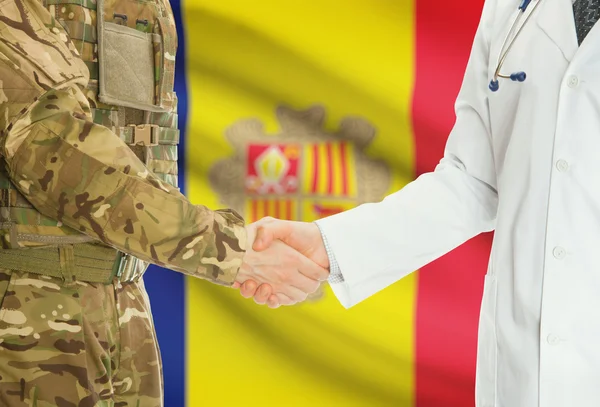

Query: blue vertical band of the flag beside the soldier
[{"left": 144, "top": 0, "right": 187, "bottom": 407}]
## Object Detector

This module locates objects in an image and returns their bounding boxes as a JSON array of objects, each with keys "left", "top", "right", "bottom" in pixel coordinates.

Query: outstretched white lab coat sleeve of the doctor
[{"left": 317, "top": 0, "right": 498, "bottom": 307}]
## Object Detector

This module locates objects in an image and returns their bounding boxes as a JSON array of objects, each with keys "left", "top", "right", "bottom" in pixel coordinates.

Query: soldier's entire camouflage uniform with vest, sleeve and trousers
[{"left": 0, "top": 0, "right": 246, "bottom": 407}]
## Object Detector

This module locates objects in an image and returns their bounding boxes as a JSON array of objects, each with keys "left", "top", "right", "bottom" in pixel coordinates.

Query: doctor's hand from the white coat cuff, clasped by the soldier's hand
[{"left": 234, "top": 217, "right": 329, "bottom": 308}]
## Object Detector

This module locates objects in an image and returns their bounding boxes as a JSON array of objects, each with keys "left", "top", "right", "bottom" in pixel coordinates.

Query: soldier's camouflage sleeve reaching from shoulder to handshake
[{"left": 0, "top": 0, "right": 246, "bottom": 285}]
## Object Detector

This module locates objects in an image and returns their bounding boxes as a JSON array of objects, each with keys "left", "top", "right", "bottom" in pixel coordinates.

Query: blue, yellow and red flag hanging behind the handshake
[{"left": 145, "top": 0, "right": 491, "bottom": 407}]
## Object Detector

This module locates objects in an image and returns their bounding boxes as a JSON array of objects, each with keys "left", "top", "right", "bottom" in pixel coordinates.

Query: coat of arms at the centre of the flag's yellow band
[{"left": 209, "top": 106, "right": 391, "bottom": 299}]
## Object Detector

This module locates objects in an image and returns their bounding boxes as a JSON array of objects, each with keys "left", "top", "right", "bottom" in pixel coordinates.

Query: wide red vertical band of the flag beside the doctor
[{"left": 413, "top": 0, "right": 490, "bottom": 407}]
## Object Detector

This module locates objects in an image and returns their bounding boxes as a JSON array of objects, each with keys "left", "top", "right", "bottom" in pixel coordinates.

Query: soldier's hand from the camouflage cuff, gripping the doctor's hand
[{"left": 233, "top": 223, "right": 329, "bottom": 306}]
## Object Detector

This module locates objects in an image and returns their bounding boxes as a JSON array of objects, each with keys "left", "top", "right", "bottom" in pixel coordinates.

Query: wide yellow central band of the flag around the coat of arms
[{"left": 182, "top": 0, "right": 416, "bottom": 407}]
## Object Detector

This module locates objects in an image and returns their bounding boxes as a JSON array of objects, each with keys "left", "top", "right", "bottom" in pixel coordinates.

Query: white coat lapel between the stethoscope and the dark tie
[{"left": 530, "top": 0, "right": 578, "bottom": 62}]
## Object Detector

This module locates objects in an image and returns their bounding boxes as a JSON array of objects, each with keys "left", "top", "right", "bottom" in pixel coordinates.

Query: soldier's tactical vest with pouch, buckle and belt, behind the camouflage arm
[{"left": 0, "top": 0, "right": 179, "bottom": 283}]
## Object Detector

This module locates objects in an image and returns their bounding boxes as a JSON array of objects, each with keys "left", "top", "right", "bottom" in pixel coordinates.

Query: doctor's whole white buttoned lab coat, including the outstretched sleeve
[{"left": 319, "top": 0, "right": 600, "bottom": 407}]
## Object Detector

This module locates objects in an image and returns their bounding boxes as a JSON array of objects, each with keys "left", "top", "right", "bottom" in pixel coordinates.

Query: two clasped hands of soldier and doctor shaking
[{"left": 233, "top": 218, "right": 329, "bottom": 308}]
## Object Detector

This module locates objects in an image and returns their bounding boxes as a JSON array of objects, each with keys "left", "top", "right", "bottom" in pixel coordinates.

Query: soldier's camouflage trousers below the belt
[{"left": 0, "top": 269, "right": 163, "bottom": 407}]
